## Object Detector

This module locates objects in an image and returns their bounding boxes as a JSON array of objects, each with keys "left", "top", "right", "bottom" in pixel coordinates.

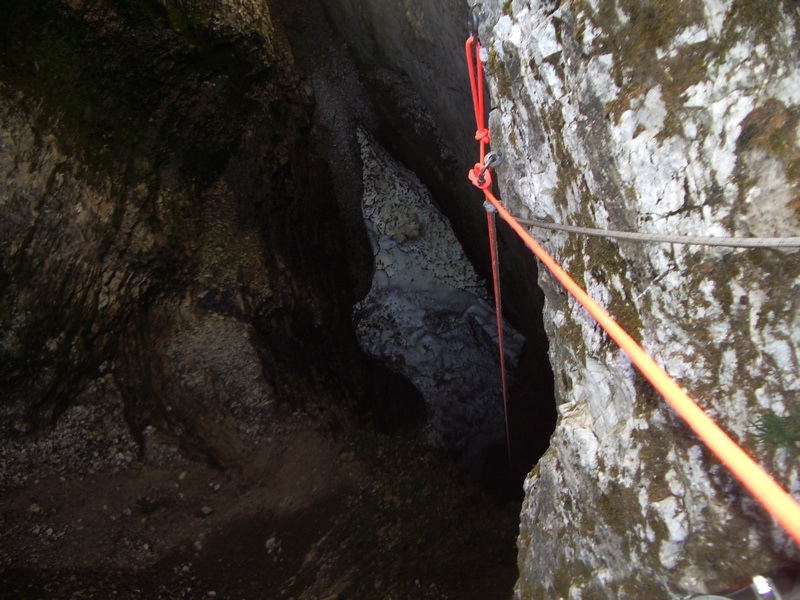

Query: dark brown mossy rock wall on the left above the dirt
[{"left": 0, "top": 0, "right": 419, "bottom": 466}]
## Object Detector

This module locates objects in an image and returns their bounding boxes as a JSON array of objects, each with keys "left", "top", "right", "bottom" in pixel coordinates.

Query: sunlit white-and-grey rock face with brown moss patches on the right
[{"left": 481, "top": 0, "right": 800, "bottom": 599}]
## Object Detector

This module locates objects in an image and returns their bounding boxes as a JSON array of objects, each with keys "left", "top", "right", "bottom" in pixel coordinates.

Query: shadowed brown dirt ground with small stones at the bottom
[{"left": 0, "top": 406, "right": 519, "bottom": 600}]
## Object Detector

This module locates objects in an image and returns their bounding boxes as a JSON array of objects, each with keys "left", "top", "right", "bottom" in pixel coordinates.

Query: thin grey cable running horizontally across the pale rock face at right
[{"left": 515, "top": 217, "right": 800, "bottom": 248}]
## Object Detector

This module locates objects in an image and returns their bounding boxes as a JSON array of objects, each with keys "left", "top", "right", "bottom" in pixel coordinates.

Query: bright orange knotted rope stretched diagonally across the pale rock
[{"left": 466, "top": 8, "right": 800, "bottom": 545}]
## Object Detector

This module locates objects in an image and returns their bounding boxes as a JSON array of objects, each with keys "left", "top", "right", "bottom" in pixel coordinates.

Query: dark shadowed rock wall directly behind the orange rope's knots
[{"left": 312, "top": 0, "right": 555, "bottom": 482}]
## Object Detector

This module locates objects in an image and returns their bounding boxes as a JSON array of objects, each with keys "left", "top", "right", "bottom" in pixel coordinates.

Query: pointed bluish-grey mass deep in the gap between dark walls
[{"left": 354, "top": 133, "right": 524, "bottom": 458}]
